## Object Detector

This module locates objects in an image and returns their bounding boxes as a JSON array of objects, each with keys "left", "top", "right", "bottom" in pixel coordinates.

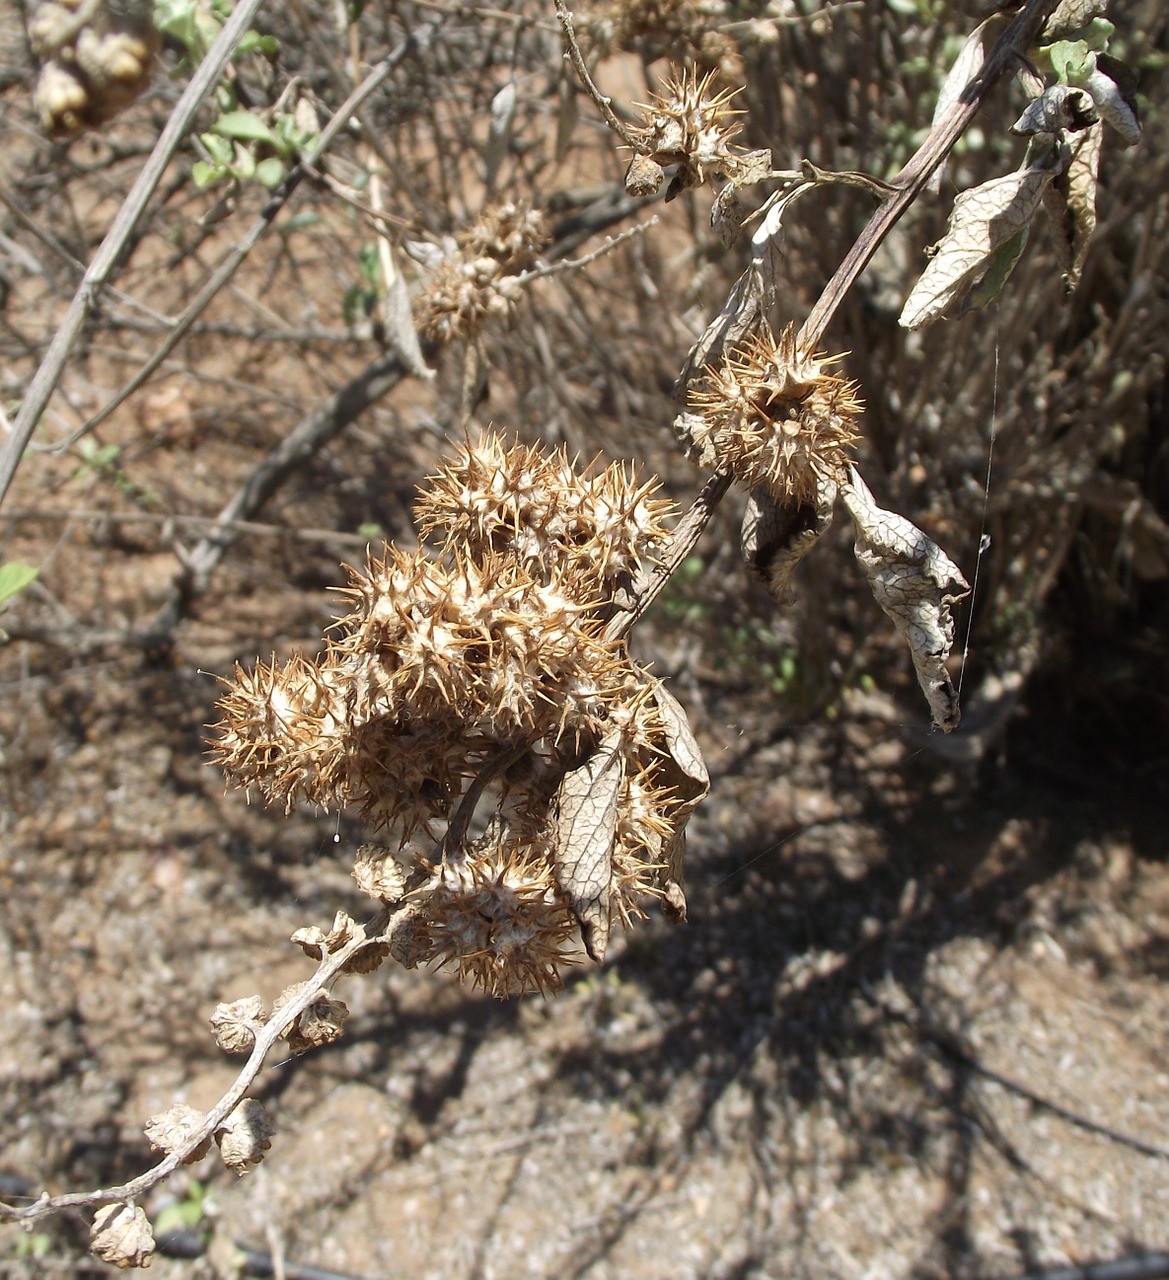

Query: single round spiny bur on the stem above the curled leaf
[{"left": 689, "top": 325, "right": 862, "bottom": 504}]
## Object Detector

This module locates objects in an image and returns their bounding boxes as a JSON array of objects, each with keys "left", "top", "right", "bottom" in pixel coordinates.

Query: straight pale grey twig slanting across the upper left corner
[{"left": 0, "top": 0, "right": 262, "bottom": 503}]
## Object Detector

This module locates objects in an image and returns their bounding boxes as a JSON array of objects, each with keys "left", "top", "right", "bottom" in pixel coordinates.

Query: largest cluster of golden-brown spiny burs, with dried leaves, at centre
[{"left": 215, "top": 434, "right": 704, "bottom": 996}]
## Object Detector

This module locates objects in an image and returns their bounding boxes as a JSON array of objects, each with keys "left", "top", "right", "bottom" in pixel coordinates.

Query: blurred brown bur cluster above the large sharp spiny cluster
[{"left": 414, "top": 201, "right": 548, "bottom": 343}]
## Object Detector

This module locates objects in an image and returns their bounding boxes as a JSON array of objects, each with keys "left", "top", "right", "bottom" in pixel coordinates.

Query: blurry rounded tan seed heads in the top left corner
[{"left": 28, "top": 0, "right": 159, "bottom": 137}]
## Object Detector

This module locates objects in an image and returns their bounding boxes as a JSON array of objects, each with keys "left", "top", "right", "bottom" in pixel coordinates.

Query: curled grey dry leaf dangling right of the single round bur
[{"left": 841, "top": 468, "right": 969, "bottom": 732}]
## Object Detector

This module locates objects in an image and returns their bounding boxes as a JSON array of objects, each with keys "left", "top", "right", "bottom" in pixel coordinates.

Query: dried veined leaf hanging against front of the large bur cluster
[{"left": 553, "top": 730, "right": 625, "bottom": 964}]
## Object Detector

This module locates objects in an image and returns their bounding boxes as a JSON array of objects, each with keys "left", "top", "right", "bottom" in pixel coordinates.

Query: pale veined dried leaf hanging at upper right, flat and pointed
[{"left": 899, "top": 148, "right": 1060, "bottom": 329}]
